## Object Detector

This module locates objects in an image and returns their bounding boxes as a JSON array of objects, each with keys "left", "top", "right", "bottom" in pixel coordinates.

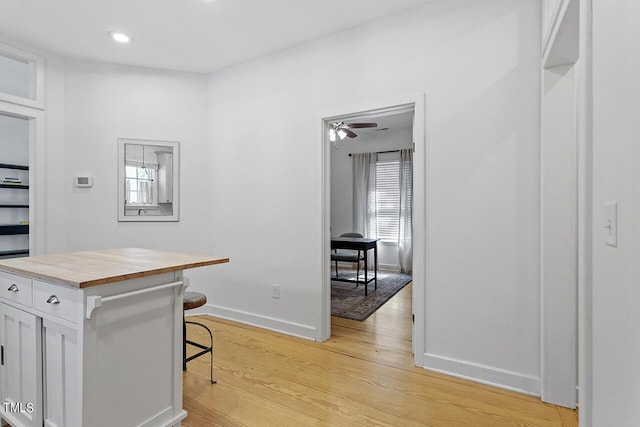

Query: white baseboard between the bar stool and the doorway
[{"left": 189, "top": 304, "right": 316, "bottom": 341}]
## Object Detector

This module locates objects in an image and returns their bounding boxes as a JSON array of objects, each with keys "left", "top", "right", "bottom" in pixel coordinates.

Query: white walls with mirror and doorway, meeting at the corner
[{"left": 1, "top": 0, "right": 540, "bottom": 393}]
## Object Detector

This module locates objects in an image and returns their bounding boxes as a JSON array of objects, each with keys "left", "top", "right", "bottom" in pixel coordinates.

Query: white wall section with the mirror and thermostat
[{"left": 40, "top": 57, "right": 224, "bottom": 288}]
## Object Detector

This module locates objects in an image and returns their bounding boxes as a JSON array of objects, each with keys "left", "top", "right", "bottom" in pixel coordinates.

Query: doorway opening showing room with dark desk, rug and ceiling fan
[{"left": 329, "top": 109, "right": 413, "bottom": 314}]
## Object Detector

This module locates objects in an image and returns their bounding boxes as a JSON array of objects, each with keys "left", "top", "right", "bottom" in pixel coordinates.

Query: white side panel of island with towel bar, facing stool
[{"left": 82, "top": 271, "right": 186, "bottom": 427}]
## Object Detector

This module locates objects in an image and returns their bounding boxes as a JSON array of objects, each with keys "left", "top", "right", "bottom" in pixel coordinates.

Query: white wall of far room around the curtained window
[{"left": 331, "top": 128, "right": 413, "bottom": 270}]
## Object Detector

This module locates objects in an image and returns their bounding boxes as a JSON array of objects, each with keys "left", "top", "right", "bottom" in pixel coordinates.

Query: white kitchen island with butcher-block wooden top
[{"left": 0, "top": 248, "right": 229, "bottom": 427}]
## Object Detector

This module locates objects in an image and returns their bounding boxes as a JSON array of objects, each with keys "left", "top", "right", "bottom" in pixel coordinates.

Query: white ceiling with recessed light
[{"left": 0, "top": 0, "right": 431, "bottom": 72}]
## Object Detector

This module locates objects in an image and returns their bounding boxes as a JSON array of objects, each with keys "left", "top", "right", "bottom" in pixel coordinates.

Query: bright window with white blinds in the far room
[{"left": 368, "top": 158, "right": 412, "bottom": 244}]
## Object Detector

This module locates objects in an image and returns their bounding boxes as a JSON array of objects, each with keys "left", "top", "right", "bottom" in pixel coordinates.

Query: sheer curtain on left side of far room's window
[{"left": 353, "top": 153, "right": 378, "bottom": 237}]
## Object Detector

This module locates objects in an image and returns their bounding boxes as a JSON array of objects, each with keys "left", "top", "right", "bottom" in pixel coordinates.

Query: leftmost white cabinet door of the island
[{"left": 0, "top": 304, "right": 43, "bottom": 427}]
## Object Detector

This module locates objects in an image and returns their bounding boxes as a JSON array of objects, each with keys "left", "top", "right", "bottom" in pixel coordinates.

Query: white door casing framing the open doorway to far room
[{"left": 318, "top": 95, "right": 427, "bottom": 366}]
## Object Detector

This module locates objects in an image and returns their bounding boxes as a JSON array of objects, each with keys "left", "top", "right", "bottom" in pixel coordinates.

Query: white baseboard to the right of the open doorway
[{"left": 423, "top": 353, "right": 540, "bottom": 397}]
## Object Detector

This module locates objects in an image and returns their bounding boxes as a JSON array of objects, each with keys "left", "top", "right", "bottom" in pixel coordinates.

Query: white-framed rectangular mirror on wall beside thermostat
[{"left": 118, "top": 138, "right": 180, "bottom": 221}]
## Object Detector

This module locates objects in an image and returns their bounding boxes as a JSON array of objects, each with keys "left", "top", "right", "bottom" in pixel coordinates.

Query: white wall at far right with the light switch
[{"left": 592, "top": 0, "right": 640, "bottom": 427}]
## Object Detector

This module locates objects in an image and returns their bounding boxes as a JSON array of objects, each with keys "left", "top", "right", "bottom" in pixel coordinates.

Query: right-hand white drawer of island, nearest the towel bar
[{"left": 33, "top": 280, "right": 80, "bottom": 323}]
